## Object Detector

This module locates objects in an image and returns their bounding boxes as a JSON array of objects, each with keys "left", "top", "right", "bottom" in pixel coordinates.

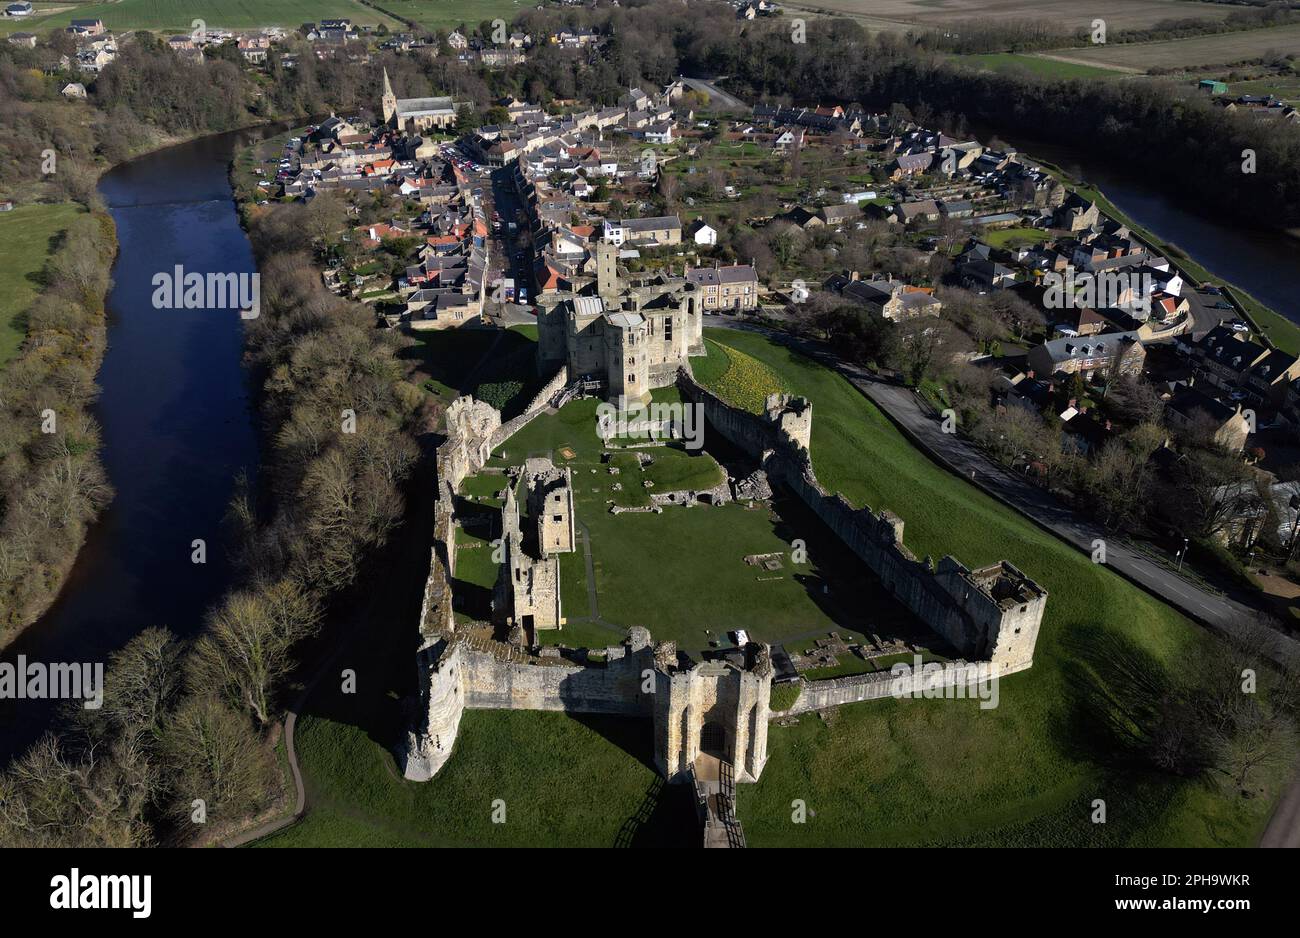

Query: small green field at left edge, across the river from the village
[{"left": 0, "top": 203, "right": 79, "bottom": 366}]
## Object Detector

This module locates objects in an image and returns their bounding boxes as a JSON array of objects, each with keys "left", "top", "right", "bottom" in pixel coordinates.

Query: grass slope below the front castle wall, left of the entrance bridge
[{"left": 257, "top": 711, "right": 697, "bottom": 847}]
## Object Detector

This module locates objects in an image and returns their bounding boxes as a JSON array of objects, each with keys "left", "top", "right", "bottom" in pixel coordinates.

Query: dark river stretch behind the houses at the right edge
[{"left": 980, "top": 130, "right": 1300, "bottom": 323}]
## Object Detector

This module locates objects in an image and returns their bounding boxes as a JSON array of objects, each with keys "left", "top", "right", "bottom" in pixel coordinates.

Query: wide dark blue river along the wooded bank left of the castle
[{"left": 0, "top": 129, "right": 276, "bottom": 764}]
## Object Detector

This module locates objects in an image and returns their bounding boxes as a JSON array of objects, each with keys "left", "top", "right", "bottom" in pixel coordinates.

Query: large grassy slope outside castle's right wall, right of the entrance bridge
[{"left": 706, "top": 330, "right": 1277, "bottom": 846}]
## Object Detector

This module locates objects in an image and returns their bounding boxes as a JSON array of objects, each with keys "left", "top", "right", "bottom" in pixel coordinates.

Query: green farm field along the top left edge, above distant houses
[{"left": 0, "top": 0, "right": 398, "bottom": 32}]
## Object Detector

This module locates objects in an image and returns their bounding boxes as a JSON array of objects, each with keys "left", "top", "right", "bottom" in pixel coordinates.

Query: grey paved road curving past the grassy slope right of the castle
[{"left": 709, "top": 317, "right": 1300, "bottom": 660}]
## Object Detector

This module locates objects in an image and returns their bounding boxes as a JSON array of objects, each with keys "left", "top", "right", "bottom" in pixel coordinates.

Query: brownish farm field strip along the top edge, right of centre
[{"left": 787, "top": 0, "right": 1236, "bottom": 30}]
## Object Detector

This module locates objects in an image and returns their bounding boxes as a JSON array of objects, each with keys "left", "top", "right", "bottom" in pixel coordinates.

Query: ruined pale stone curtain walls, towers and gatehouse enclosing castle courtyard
[{"left": 402, "top": 361, "right": 1048, "bottom": 821}]
